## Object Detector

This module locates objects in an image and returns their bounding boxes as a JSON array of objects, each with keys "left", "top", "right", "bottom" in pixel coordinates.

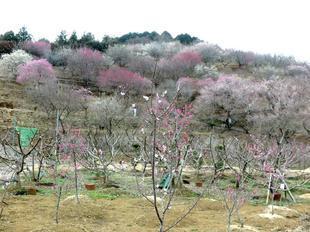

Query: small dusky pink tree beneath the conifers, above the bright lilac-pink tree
[{"left": 23, "top": 41, "right": 51, "bottom": 58}]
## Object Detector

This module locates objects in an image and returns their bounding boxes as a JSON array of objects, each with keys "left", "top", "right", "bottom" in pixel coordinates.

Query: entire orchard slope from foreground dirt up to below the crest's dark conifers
[{"left": 0, "top": 34, "right": 310, "bottom": 232}]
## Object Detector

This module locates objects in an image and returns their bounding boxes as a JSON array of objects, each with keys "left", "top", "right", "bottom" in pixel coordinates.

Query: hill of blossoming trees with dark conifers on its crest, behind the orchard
[{"left": 0, "top": 28, "right": 310, "bottom": 140}]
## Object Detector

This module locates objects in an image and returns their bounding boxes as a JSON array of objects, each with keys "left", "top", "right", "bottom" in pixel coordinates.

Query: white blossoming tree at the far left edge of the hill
[{"left": 0, "top": 50, "right": 32, "bottom": 78}]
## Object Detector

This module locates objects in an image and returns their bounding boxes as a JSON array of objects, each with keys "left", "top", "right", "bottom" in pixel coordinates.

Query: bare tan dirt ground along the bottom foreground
[{"left": 0, "top": 195, "right": 310, "bottom": 232}]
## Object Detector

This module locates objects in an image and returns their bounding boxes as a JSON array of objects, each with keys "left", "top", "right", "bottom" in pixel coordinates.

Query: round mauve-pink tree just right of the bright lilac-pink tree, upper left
[{"left": 68, "top": 48, "right": 104, "bottom": 84}]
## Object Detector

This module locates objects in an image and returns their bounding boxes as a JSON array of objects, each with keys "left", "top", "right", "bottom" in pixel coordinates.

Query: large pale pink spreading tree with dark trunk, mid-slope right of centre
[{"left": 196, "top": 76, "right": 260, "bottom": 132}]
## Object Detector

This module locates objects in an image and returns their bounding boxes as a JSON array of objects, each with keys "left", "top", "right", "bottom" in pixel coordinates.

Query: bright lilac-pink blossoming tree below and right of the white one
[{"left": 16, "top": 59, "right": 55, "bottom": 83}]
